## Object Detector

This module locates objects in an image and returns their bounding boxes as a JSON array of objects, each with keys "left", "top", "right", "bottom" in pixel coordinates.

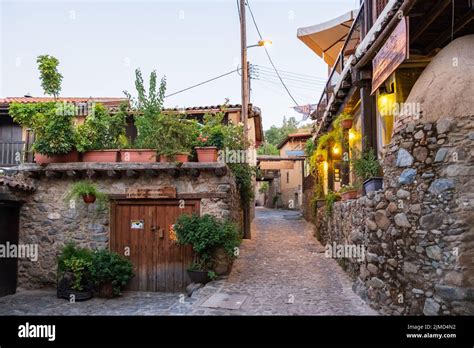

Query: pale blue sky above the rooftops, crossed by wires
[{"left": 0, "top": 0, "right": 359, "bottom": 129}]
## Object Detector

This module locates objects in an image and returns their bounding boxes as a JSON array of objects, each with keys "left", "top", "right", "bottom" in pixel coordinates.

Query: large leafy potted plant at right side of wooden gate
[{"left": 175, "top": 214, "right": 240, "bottom": 283}]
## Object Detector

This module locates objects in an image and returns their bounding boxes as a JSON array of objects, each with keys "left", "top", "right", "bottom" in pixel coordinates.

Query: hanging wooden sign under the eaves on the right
[{"left": 372, "top": 17, "right": 410, "bottom": 94}]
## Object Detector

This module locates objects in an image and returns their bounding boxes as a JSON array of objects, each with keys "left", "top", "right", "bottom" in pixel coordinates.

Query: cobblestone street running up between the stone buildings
[{"left": 0, "top": 208, "right": 376, "bottom": 315}]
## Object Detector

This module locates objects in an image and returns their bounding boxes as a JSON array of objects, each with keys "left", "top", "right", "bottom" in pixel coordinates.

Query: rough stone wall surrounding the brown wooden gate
[{"left": 18, "top": 164, "right": 242, "bottom": 288}]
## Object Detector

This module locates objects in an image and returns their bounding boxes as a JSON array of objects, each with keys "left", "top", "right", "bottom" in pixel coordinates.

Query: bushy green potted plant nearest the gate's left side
[{"left": 91, "top": 250, "right": 133, "bottom": 298}]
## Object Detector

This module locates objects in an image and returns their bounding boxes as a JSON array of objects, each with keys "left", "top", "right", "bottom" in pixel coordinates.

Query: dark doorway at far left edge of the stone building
[{"left": 0, "top": 202, "right": 20, "bottom": 296}]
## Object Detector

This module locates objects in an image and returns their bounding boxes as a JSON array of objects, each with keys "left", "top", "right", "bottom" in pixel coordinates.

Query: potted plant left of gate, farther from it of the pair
[{"left": 57, "top": 243, "right": 93, "bottom": 301}]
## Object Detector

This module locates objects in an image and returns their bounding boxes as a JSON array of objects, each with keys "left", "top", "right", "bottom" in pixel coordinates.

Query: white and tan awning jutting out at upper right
[{"left": 298, "top": 11, "right": 357, "bottom": 67}]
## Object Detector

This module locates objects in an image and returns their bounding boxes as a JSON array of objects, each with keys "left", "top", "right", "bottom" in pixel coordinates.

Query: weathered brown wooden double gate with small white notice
[{"left": 110, "top": 200, "right": 200, "bottom": 292}]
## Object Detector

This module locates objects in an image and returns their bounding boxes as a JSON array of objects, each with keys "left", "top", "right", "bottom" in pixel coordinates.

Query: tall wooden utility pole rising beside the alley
[{"left": 240, "top": 0, "right": 251, "bottom": 239}]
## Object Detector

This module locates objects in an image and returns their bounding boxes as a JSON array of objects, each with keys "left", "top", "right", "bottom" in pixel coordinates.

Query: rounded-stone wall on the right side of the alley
[{"left": 316, "top": 116, "right": 474, "bottom": 315}]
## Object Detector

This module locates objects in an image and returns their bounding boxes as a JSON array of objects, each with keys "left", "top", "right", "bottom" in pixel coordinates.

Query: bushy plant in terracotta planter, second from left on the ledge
[{"left": 76, "top": 104, "right": 126, "bottom": 162}]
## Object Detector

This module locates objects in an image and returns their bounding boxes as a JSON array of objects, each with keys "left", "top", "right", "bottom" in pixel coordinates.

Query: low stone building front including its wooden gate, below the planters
[{"left": 0, "top": 162, "right": 243, "bottom": 293}]
